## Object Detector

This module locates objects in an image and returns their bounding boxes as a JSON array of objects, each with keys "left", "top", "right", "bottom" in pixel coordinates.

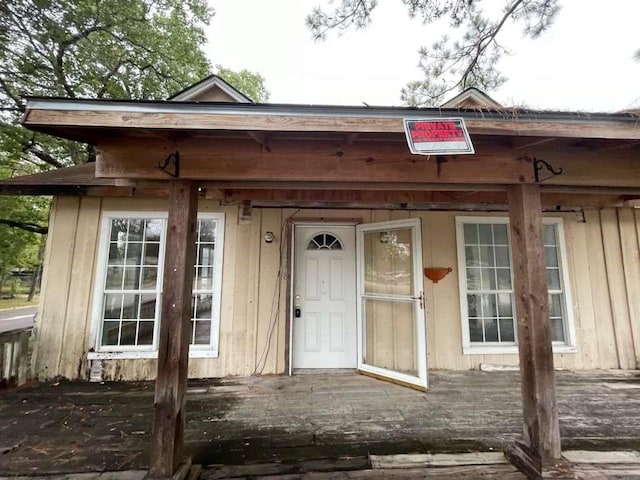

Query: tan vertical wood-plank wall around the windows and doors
[{"left": 34, "top": 197, "right": 640, "bottom": 380}]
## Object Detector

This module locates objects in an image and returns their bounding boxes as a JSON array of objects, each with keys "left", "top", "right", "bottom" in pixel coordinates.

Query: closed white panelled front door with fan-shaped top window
[{"left": 292, "top": 225, "right": 357, "bottom": 368}]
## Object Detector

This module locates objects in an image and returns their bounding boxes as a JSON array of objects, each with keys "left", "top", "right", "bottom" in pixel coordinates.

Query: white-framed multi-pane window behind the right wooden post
[{"left": 456, "top": 217, "right": 575, "bottom": 354}]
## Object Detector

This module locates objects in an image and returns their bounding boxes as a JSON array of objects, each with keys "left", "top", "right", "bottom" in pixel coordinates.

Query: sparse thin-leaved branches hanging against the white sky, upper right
[{"left": 307, "top": 0, "right": 560, "bottom": 106}]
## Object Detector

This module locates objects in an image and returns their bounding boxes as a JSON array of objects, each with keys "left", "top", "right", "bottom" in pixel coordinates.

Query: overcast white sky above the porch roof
[{"left": 207, "top": 0, "right": 640, "bottom": 112}]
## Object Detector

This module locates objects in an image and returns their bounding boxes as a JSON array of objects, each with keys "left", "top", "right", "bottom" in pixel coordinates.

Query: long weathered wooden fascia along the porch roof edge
[{"left": 24, "top": 97, "right": 640, "bottom": 143}]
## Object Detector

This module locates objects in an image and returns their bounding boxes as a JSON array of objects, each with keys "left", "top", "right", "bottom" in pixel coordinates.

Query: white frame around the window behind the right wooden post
[{"left": 455, "top": 216, "right": 578, "bottom": 355}]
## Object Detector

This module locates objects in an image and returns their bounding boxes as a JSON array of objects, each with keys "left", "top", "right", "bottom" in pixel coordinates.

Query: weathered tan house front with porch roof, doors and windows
[{"left": 2, "top": 77, "right": 640, "bottom": 388}]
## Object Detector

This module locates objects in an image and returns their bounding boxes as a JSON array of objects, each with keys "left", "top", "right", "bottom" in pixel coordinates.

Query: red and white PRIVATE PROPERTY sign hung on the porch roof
[{"left": 404, "top": 118, "right": 474, "bottom": 155}]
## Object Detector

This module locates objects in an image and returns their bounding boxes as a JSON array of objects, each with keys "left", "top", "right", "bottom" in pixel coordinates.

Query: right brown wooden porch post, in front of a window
[{"left": 507, "top": 185, "right": 561, "bottom": 477}]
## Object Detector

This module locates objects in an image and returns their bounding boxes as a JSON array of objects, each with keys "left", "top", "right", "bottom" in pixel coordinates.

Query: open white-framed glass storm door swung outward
[{"left": 357, "top": 219, "right": 427, "bottom": 389}]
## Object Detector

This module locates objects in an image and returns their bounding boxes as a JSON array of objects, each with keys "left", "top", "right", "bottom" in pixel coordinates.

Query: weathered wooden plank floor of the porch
[{"left": 0, "top": 371, "right": 640, "bottom": 475}]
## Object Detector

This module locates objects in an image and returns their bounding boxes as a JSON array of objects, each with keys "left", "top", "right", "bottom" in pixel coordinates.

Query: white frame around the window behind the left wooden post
[{"left": 87, "top": 211, "right": 225, "bottom": 360}]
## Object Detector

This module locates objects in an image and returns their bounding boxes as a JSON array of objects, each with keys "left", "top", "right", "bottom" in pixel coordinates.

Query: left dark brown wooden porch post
[{"left": 148, "top": 180, "right": 198, "bottom": 478}]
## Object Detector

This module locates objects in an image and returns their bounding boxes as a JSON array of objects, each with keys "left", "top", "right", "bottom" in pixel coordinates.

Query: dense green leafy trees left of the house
[{"left": 0, "top": 0, "right": 213, "bottom": 283}]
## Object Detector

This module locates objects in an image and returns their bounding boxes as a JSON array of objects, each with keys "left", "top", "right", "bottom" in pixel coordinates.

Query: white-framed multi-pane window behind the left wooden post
[{"left": 90, "top": 212, "right": 224, "bottom": 358}]
